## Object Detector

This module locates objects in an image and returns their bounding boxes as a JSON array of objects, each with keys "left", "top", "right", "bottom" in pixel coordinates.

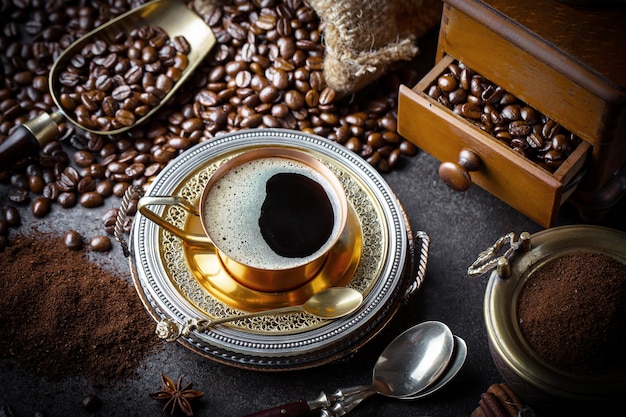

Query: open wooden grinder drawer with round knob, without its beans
[{"left": 398, "top": 55, "right": 591, "bottom": 227}]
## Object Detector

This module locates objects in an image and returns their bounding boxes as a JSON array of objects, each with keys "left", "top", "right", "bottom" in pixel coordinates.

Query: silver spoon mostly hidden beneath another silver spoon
[{"left": 320, "top": 336, "right": 467, "bottom": 417}]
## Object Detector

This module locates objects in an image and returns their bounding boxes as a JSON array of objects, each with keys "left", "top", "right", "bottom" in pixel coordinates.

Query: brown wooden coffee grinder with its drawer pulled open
[{"left": 398, "top": 0, "right": 626, "bottom": 227}]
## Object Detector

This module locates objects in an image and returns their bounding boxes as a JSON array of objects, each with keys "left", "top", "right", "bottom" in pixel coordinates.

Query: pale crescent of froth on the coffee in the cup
[{"left": 204, "top": 157, "right": 341, "bottom": 269}]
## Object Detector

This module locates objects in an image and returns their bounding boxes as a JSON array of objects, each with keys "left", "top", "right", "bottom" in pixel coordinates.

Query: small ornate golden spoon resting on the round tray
[{"left": 157, "top": 287, "right": 363, "bottom": 342}]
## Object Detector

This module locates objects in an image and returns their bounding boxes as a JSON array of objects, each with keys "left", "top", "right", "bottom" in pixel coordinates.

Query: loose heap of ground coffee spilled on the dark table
[{"left": 0, "top": 233, "right": 161, "bottom": 383}]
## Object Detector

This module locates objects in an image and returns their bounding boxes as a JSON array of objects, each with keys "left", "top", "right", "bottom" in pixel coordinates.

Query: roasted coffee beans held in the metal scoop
[{"left": 57, "top": 25, "right": 191, "bottom": 132}]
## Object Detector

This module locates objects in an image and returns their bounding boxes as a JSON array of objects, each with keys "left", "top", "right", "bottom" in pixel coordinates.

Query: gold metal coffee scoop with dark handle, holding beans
[{"left": 0, "top": 0, "right": 216, "bottom": 170}]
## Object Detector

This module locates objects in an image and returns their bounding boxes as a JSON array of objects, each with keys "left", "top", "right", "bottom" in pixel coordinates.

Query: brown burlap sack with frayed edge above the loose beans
[{"left": 308, "top": 0, "right": 442, "bottom": 94}]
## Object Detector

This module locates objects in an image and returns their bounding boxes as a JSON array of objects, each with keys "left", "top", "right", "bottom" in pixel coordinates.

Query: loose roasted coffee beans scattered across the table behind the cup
[{"left": 0, "top": 0, "right": 419, "bottom": 250}]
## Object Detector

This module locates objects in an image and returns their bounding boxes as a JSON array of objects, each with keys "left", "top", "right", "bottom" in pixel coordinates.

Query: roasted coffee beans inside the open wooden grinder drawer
[{"left": 427, "top": 61, "right": 580, "bottom": 172}]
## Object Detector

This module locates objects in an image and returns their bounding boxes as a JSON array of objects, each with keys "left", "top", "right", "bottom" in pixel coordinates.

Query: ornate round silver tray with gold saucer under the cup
[{"left": 128, "top": 129, "right": 428, "bottom": 371}]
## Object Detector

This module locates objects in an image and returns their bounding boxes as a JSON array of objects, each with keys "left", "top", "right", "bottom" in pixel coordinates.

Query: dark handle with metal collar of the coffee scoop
[{"left": 0, "top": 113, "right": 63, "bottom": 170}]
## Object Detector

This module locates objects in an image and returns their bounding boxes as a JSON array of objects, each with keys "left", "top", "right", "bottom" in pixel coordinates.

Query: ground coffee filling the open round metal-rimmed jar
[{"left": 518, "top": 253, "right": 626, "bottom": 375}]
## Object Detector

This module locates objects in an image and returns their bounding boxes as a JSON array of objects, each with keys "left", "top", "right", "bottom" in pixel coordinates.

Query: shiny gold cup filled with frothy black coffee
[{"left": 138, "top": 147, "right": 348, "bottom": 292}]
